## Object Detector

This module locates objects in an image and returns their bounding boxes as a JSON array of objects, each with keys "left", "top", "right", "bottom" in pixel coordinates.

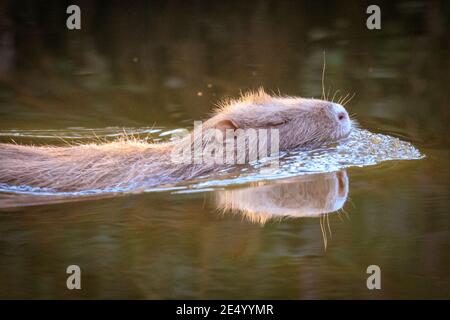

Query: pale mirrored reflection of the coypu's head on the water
[{"left": 215, "top": 171, "right": 348, "bottom": 247}]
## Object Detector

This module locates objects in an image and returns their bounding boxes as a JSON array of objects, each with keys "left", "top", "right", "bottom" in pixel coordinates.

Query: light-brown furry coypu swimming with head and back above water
[{"left": 0, "top": 89, "right": 352, "bottom": 192}]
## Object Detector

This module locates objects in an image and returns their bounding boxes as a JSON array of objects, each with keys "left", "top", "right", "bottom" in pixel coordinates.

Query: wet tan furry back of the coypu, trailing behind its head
[{"left": 0, "top": 141, "right": 174, "bottom": 192}]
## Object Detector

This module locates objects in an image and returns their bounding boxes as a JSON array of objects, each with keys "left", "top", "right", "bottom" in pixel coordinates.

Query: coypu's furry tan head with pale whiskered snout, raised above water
[{"left": 206, "top": 89, "right": 353, "bottom": 150}]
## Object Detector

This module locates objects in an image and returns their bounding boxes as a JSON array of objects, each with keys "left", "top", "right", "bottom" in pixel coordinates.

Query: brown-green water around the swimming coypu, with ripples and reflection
[{"left": 0, "top": 1, "right": 450, "bottom": 299}]
